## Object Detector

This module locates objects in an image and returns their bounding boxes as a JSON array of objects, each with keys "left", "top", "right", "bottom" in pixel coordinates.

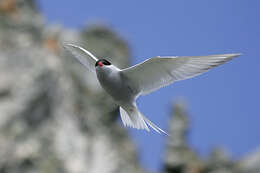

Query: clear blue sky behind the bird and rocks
[{"left": 38, "top": 0, "right": 260, "bottom": 170}]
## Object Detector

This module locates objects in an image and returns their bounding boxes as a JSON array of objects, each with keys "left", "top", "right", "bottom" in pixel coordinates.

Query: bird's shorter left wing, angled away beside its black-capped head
[{"left": 63, "top": 44, "right": 98, "bottom": 73}]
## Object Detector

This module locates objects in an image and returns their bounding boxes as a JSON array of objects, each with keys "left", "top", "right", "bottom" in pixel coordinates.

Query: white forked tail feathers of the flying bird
[{"left": 120, "top": 107, "right": 169, "bottom": 136}]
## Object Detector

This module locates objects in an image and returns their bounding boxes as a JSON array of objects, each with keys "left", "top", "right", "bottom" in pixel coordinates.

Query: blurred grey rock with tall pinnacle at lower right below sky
[{"left": 163, "top": 103, "right": 260, "bottom": 173}]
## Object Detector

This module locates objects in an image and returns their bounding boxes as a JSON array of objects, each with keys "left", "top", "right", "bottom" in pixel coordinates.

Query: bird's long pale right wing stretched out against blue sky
[{"left": 122, "top": 54, "right": 240, "bottom": 95}]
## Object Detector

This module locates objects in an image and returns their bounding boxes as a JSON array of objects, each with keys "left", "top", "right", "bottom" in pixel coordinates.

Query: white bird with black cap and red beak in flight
[{"left": 64, "top": 44, "right": 240, "bottom": 135}]
